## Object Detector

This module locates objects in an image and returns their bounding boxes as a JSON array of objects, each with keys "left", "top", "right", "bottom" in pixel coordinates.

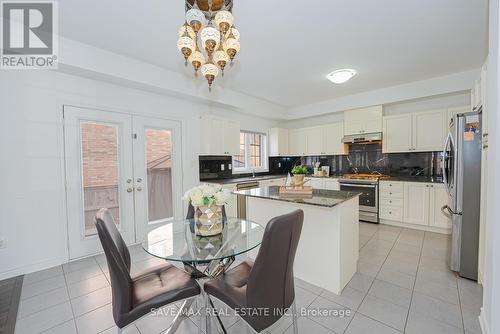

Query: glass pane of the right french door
[{"left": 144, "top": 129, "right": 174, "bottom": 222}]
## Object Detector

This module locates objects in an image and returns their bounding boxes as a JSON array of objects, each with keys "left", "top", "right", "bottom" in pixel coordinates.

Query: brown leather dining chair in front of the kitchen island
[{"left": 204, "top": 210, "right": 304, "bottom": 334}]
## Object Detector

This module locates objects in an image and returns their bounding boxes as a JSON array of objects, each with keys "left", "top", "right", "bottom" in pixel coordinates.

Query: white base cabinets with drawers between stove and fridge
[{"left": 379, "top": 181, "right": 451, "bottom": 233}]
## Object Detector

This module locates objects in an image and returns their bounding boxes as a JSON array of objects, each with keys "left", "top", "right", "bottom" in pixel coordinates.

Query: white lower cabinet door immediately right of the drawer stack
[{"left": 403, "top": 182, "right": 430, "bottom": 225}]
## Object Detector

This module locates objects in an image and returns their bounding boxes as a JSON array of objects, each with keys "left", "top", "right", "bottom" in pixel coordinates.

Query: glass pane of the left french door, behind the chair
[{"left": 80, "top": 122, "right": 120, "bottom": 236}]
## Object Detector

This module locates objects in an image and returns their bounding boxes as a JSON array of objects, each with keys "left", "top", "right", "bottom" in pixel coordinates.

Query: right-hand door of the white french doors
[{"left": 133, "top": 116, "right": 183, "bottom": 242}]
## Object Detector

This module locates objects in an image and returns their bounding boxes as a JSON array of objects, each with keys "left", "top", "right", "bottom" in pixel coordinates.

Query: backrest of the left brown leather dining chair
[{"left": 95, "top": 209, "right": 132, "bottom": 324}]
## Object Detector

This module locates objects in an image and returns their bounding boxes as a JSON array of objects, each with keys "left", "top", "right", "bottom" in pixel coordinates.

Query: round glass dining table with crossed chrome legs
[{"left": 142, "top": 218, "right": 264, "bottom": 333}]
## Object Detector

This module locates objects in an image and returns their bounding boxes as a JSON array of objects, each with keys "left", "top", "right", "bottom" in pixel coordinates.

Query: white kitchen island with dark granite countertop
[{"left": 234, "top": 186, "right": 359, "bottom": 294}]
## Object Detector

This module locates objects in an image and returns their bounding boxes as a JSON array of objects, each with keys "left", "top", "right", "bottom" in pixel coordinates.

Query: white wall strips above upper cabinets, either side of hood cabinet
[{"left": 283, "top": 92, "right": 470, "bottom": 129}]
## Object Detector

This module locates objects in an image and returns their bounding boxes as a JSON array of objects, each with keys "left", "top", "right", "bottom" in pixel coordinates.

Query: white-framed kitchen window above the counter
[{"left": 233, "top": 132, "right": 267, "bottom": 173}]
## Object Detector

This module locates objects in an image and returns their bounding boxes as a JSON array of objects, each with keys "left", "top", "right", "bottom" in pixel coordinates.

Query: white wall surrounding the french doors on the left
[{"left": 0, "top": 71, "right": 274, "bottom": 279}]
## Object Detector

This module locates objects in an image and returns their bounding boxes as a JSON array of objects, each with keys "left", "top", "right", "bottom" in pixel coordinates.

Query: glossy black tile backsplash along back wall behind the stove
[{"left": 269, "top": 143, "right": 442, "bottom": 177}]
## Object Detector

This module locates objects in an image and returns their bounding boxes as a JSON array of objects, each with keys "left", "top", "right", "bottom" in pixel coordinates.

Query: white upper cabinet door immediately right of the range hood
[{"left": 382, "top": 114, "right": 412, "bottom": 153}]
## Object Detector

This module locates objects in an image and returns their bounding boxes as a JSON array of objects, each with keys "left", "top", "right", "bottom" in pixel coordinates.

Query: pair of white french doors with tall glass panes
[{"left": 64, "top": 106, "right": 182, "bottom": 259}]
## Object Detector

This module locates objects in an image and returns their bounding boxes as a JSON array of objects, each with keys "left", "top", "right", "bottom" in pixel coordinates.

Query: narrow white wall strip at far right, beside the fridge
[{"left": 480, "top": 0, "right": 500, "bottom": 334}]
